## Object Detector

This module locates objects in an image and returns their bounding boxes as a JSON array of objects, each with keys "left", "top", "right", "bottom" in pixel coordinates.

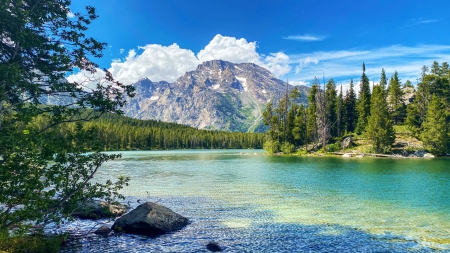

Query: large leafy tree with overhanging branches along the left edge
[{"left": 0, "top": 0, "right": 133, "bottom": 233}]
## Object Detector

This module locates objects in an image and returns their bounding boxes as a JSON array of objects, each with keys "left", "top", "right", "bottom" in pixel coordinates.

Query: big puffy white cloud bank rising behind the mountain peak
[{"left": 68, "top": 34, "right": 291, "bottom": 84}]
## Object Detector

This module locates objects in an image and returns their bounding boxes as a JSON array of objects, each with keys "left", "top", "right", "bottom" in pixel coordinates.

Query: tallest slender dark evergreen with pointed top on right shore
[{"left": 356, "top": 63, "right": 370, "bottom": 133}]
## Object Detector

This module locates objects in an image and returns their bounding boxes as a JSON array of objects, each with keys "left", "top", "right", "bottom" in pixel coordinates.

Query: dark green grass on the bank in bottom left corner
[{"left": 0, "top": 231, "right": 67, "bottom": 253}]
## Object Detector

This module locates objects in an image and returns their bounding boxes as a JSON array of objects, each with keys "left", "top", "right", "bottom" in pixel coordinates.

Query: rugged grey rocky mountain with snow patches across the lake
[{"left": 124, "top": 60, "right": 308, "bottom": 132}]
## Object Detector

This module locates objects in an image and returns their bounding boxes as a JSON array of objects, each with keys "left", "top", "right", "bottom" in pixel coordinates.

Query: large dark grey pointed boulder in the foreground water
[{"left": 112, "top": 202, "right": 189, "bottom": 236}]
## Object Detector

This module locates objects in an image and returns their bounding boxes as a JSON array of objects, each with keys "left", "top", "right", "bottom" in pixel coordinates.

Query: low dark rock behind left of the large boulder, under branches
[{"left": 72, "top": 200, "right": 128, "bottom": 220}]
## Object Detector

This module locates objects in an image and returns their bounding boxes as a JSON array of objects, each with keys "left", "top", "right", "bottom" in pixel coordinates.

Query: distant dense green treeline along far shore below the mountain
[{"left": 83, "top": 114, "right": 265, "bottom": 150}]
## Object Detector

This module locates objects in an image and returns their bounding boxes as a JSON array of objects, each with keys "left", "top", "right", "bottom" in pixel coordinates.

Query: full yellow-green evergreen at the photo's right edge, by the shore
[{"left": 421, "top": 95, "right": 450, "bottom": 155}]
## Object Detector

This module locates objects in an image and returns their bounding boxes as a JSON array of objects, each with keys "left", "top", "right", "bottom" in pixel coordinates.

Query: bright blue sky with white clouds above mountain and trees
[{"left": 70, "top": 0, "right": 450, "bottom": 90}]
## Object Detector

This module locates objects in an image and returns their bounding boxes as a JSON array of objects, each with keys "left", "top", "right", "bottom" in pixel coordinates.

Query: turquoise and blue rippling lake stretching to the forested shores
[{"left": 60, "top": 150, "right": 450, "bottom": 252}]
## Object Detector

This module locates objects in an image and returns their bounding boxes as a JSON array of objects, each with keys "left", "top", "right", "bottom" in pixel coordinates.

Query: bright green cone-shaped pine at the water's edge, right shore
[{"left": 365, "top": 85, "right": 395, "bottom": 153}]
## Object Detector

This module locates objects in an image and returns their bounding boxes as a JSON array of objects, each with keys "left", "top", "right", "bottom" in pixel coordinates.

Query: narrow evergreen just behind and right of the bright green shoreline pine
[{"left": 388, "top": 71, "right": 406, "bottom": 124}]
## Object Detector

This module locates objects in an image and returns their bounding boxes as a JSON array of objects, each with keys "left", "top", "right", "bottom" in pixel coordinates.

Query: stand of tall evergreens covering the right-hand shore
[{"left": 263, "top": 62, "right": 450, "bottom": 156}]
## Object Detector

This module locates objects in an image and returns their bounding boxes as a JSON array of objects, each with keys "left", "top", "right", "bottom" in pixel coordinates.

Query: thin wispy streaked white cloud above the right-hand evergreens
[{"left": 289, "top": 45, "right": 450, "bottom": 87}]
